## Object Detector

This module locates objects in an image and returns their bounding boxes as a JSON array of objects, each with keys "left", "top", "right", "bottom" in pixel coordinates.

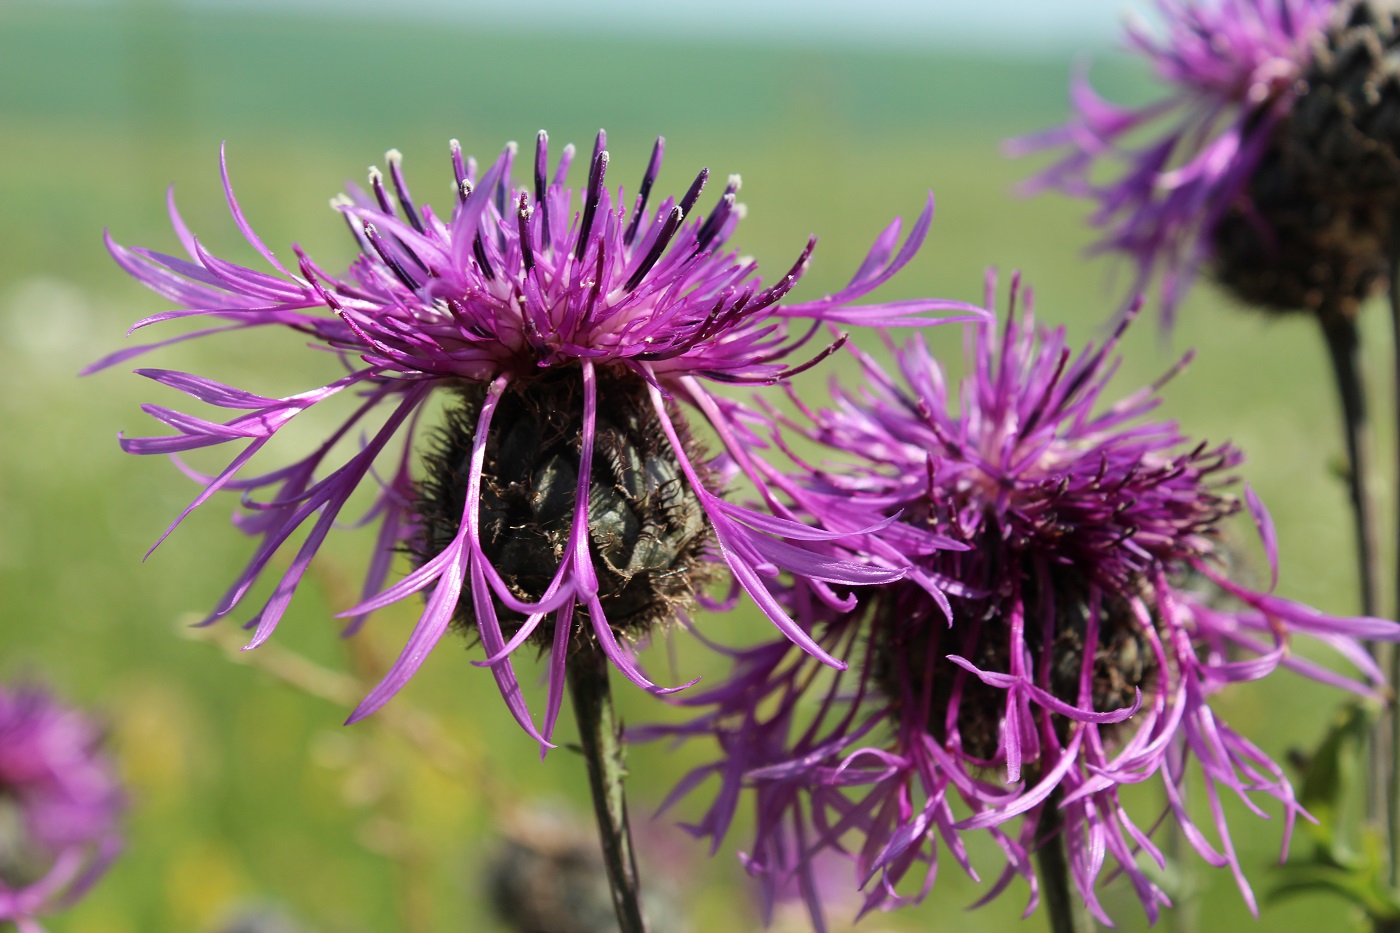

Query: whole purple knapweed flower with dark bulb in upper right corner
[{"left": 1011, "top": 0, "right": 1400, "bottom": 325}]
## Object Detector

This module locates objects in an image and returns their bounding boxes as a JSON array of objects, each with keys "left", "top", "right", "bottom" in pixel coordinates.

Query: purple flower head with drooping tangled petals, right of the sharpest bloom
[{"left": 638, "top": 273, "right": 1400, "bottom": 926}]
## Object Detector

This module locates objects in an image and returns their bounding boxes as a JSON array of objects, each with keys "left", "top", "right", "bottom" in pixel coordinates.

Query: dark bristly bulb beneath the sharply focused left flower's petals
[{"left": 414, "top": 368, "right": 710, "bottom": 646}]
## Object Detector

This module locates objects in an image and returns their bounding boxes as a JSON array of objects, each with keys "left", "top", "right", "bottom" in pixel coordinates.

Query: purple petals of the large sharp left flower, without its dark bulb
[{"left": 91, "top": 132, "right": 976, "bottom": 744}]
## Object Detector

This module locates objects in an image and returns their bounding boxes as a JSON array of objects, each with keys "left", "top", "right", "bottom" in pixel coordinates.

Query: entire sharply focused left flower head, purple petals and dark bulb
[{"left": 94, "top": 132, "right": 976, "bottom": 745}]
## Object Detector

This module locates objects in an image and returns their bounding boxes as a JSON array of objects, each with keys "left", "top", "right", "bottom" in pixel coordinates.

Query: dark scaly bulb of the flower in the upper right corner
[{"left": 1211, "top": 0, "right": 1400, "bottom": 317}]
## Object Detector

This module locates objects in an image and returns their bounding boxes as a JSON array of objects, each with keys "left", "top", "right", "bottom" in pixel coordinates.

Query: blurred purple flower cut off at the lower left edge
[{"left": 0, "top": 686, "right": 126, "bottom": 933}]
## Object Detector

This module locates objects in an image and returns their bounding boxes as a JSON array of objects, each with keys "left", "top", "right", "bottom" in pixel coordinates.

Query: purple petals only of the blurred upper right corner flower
[{"left": 1009, "top": 0, "right": 1338, "bottom": 325}]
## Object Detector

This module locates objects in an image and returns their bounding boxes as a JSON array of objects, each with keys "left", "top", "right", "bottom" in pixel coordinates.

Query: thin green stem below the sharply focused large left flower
[{"left": 568, "top": 646, "right": 647, "bottom": 933}]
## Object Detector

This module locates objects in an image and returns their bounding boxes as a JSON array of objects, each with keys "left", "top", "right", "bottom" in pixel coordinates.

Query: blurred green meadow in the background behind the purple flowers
[{"left": 0, "top": 3, "right": 1389, "bottom": 933}]
